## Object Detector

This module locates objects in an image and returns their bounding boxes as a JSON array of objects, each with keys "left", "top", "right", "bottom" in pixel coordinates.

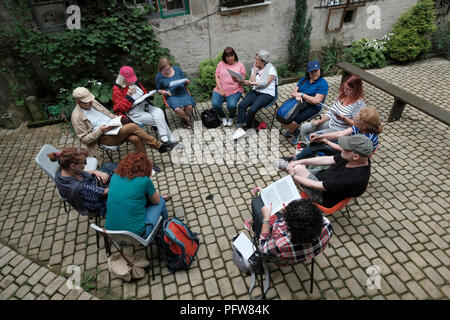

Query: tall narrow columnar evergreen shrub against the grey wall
[{"left": 288, "top": 0, "right": 312, "bottom": 72}]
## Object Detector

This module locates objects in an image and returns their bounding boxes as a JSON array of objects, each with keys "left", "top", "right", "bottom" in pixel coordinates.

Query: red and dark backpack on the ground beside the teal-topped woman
[{"left": 161, "top": 218, "right": 199, "bottom": 273}]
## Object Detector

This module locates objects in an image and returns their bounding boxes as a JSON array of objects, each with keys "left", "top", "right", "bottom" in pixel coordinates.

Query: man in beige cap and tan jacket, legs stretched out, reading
[{"left": 71, "top": 87, "right": 172, "bottom": 157}]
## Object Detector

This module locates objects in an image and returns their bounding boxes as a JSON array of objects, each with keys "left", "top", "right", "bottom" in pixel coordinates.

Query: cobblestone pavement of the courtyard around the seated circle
[{"left": 0, "top": 58, "right": 450, "bottom": 300}]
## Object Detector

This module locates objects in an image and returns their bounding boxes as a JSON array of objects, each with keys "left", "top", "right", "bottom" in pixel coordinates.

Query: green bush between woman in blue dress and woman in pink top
[{"left": 189, "top": 52, "right": 222, "bottom": 102}]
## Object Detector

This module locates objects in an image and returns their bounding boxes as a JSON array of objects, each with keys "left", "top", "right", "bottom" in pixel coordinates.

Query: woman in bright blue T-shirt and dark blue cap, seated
[{"left": 282, "top": 61, "right": 328, "bottom": 145}]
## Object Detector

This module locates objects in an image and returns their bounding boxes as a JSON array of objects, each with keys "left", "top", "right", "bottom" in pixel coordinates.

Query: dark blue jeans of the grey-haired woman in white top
[{"left": 236, "top": 90, "right": 274, "bottom": 128}]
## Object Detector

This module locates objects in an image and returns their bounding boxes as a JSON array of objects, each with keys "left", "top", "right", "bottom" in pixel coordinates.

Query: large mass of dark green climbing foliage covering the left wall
[{"left": 0, "top": 1, "right": 169, "bottom": 114}]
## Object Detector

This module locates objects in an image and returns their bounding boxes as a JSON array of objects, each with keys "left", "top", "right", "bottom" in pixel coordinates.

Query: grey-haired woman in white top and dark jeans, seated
[{"left": 233, "top": 50, "right": 278, "bottom": 136}]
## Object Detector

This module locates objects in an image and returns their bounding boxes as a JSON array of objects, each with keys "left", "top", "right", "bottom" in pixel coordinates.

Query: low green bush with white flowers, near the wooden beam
[{"left": 344, "top": 38, "right": 386, "bottom": 69}]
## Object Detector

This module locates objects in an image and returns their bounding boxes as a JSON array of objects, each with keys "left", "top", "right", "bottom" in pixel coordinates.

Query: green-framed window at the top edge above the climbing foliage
[{"left": 124, "top": 0, "right": 190, "bottom": 18}]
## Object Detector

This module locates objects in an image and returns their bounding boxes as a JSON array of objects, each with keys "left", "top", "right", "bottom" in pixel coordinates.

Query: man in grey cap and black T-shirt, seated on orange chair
[{"left": 286, "top": 134, "right": 373, "bottom": 208}]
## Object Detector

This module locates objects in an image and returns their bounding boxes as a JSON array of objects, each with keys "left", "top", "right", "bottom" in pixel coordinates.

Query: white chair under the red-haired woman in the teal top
[{"left": 90, "top": 216, "right": 163, "bottom": 280}]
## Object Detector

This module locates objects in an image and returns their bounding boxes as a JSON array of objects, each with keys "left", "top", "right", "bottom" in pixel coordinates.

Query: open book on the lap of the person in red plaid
[{"left": 261, "top": 175, "right": 300, "bottom": 215}]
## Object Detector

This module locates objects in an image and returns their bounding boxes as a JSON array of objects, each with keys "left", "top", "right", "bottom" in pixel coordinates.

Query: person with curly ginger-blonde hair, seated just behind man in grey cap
[{"left": 282, "top": 107, "right": 383, "bottom": 166}]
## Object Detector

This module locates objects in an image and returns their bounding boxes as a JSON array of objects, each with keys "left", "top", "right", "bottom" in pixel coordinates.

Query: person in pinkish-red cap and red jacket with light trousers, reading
[{"left": 112, "top": 66, "right": 177, "bottom": 148}]
